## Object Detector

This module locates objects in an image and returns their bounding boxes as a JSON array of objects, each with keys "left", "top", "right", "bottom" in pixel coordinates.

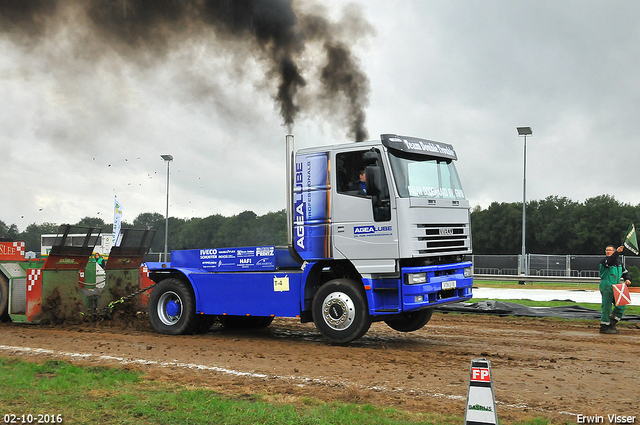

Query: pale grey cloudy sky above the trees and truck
[{"left": 0, "top": 0, "right": 640, "bottom": 231}]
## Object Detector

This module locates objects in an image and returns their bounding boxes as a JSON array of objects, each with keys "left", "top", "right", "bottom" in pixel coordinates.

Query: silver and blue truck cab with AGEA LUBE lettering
[{"left": 293, "top": 134, "right": 471, "bottom": 273}]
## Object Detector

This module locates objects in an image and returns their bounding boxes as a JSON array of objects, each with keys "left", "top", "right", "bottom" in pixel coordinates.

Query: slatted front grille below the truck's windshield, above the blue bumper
[{"left": 412, "top": 224, "right": 471, "bottom": 256}]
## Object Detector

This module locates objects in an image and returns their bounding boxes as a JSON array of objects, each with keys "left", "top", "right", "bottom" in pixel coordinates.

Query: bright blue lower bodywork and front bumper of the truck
[{"left": 147, "top": 246, "right": 473, "bottom": 317}]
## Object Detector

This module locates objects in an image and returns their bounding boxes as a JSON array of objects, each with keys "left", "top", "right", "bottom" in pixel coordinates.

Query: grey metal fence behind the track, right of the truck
[{"left": 472, "top": 254, "right": 640, "bottom": 277}]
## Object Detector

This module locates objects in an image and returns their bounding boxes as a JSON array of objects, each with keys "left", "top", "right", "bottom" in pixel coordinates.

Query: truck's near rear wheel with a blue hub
[{"left": 148, "top": 278, "right": 198, "bottom": 335}]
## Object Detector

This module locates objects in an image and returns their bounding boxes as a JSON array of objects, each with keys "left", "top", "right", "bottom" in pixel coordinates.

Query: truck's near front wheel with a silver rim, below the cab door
[{"left": 312, "top": 279, "right": 371, "bottom": 344}]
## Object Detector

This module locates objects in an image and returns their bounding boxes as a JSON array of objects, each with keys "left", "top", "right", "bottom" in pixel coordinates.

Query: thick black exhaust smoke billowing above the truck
[{"left": 0, "top": 0, "right": 371, "bottom": 141}]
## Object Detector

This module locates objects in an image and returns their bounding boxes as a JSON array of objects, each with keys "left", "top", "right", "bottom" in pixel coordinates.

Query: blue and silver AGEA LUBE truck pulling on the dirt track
[{"left": 148, "top": 134, "right": 473, "bottom": 343}]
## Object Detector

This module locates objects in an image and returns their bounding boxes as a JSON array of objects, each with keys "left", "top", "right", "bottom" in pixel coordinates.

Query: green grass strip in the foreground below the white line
[{"left": 0, "top": 358, "right": 564, "bottom": 425}]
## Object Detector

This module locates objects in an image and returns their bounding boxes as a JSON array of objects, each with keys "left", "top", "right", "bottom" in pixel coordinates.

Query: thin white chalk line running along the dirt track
[{"left": 0, "top": 345, "right": 577, "bottom": 416}]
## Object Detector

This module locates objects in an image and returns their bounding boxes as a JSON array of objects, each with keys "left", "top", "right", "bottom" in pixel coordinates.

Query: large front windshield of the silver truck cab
[{"left": 389, "top": 149, "right": 464, "bottom": 199}]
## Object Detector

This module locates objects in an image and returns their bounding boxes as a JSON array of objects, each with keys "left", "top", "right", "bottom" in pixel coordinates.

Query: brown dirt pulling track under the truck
[{"left": 0, "top": 313, "right": 640, "bottom": 423}]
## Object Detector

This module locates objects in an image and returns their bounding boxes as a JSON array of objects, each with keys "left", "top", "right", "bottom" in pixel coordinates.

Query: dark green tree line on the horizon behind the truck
[{"left": 0, "top": 195, "right": 640, "bottom": 255}]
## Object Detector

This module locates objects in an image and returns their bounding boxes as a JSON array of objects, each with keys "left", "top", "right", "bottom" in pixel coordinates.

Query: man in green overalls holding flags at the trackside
[{"left": 600, "top": 245, "right": 631, "bottom": 334}]
